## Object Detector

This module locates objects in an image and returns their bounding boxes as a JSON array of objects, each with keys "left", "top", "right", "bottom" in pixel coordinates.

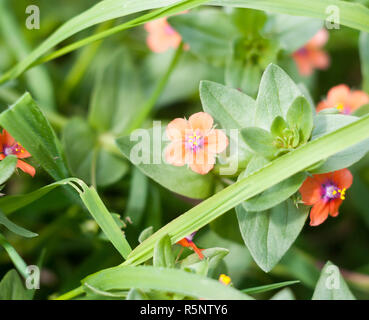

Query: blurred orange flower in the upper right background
[{"left": 292, "top": 29, "right": 329, "bottom": 76}]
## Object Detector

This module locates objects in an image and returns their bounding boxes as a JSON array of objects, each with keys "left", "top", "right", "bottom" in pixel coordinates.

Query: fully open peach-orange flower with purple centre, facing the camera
[{"left": 165, "top": 112, "right": 228, "bottom": 174}]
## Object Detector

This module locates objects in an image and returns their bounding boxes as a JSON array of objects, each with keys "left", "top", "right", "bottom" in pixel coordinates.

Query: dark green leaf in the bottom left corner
[{"left": 0, "top": 269, "right": 32, "bottom": 300}]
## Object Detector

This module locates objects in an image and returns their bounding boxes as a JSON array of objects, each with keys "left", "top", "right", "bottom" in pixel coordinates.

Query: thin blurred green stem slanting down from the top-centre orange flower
[{"left": 125, "top": 42, "right": 184, "bottom": 134}]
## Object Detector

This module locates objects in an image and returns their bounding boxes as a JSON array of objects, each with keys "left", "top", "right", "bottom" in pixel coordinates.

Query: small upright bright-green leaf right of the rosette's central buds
[{"left": 287, "top": 97, "right": 314, "bottom": 144}]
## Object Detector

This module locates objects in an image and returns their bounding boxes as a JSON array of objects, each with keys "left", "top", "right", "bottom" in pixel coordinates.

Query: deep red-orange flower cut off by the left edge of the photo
[{"left": 0, "top": 130, "right": 36, "bottom": 177}]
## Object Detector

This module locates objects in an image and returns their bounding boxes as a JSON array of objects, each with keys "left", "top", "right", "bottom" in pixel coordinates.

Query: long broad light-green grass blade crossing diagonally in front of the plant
[{"left": 124, "top": 112, "right": 369, "bottom": 265}]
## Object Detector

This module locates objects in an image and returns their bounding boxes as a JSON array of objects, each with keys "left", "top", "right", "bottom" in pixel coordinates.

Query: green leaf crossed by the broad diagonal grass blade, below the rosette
[{"left": 238, "top": 156, "right": 306, "bottom": 212}]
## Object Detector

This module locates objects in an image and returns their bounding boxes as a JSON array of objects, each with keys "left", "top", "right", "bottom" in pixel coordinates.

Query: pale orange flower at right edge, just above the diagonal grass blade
[{"left": 317, "top": 84, "right": 369, "bottom": 114}]
